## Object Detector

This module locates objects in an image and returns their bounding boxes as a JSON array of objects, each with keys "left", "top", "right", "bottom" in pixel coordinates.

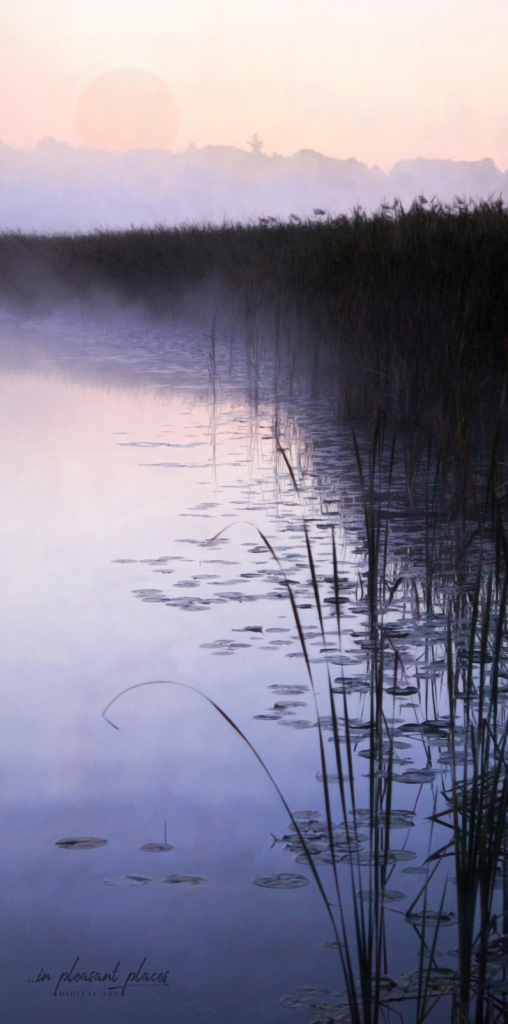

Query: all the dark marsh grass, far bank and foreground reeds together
[{"left": 85, "top": 202, "right": 508, "bottom": 1024}]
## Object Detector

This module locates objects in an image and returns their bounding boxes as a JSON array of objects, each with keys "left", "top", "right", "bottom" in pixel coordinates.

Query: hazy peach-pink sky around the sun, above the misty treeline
[{"left": 0, "top": 0, "right": 508, "bottom": 168}]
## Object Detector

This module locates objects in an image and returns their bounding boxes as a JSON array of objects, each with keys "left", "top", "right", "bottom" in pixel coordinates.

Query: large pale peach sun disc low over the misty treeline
[{"left": 76, "top": 68, "right": 179, "bottom": 152}]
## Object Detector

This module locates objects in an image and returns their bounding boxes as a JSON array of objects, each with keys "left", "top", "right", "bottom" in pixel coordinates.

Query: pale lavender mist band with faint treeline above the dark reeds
[{"left": 0, "top": 137, "right": 508, "bottom": 232}]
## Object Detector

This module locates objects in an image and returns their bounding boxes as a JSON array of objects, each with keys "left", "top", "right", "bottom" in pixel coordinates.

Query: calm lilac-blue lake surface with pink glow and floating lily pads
[{"left": 0, "top": 310, "right": 504, "bottom": 1024}]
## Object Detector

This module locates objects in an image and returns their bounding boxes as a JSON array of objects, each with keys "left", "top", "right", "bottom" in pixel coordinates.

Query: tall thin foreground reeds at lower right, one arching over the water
[{"left": 103, "top": 412, "right": 508, "bottom": 1024}]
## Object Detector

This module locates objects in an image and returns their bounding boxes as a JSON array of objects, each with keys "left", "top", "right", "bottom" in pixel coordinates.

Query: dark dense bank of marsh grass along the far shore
[{"left": 5, "top": 198, "right": 508, "bottom": 438}]
